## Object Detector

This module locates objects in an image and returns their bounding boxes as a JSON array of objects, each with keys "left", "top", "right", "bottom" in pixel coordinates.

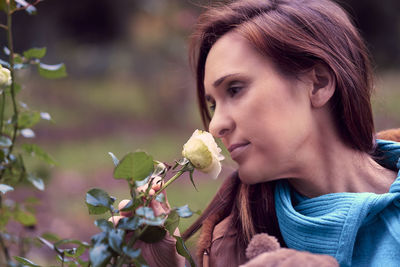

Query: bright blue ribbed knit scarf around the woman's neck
[{"left": 275, "top": 140, "right": 400, "bottom": 266}]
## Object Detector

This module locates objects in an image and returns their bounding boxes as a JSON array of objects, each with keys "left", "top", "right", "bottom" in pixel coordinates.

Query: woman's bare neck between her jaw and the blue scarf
[{"left": 289, "top": 112, "right": 397, "bottom": 197}]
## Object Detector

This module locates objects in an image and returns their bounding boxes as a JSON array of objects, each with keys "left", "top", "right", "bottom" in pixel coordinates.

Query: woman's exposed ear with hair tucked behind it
[{"left": 309, "top": 64, "right": 336, "bottom": 108}]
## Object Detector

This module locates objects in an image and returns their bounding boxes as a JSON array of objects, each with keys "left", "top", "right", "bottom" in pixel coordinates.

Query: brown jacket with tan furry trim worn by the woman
[{"left": 196, "top": 128, "right": 400, "bottom": 267}]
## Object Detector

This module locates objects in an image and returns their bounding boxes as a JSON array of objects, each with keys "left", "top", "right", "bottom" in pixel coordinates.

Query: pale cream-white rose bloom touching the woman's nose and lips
[{"left": 182, "top": 130, "right": 224, "bottom": 179}]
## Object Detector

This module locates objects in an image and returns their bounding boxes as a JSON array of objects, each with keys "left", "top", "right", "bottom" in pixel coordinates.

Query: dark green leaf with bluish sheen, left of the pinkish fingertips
[{"left": 86, "top": 188, "right": 113, "bottom": 214}]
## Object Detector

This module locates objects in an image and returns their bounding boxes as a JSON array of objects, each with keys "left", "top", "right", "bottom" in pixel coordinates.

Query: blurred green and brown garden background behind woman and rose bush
[{"left": 0, "top": 0, "right": 400, "bottom": 263}]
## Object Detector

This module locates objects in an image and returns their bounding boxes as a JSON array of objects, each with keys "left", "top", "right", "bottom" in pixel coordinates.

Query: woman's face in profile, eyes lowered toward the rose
[{"left": 204, "top": 32, "right": 312, "bottom": 184}]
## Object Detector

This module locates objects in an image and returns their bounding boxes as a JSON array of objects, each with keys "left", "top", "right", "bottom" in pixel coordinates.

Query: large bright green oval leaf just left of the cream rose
[{"left": 114, "top": 152, "right": 154, "bottom": 181}]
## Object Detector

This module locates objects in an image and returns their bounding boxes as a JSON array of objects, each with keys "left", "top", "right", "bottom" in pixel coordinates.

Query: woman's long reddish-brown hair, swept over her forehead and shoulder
[{"left": 184, "top": 0, "right": 374, "bottom": 260}]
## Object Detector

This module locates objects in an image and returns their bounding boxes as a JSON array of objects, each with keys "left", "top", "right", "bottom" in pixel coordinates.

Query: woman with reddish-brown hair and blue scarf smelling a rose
[{"left": 114, "top": 0, "right": 400, "bottom": 266}]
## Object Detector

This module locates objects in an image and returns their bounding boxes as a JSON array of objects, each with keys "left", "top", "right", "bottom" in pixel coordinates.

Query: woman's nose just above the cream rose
[{"left": 209, "top": 108, "right": 235, "bottom": 138}]
